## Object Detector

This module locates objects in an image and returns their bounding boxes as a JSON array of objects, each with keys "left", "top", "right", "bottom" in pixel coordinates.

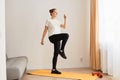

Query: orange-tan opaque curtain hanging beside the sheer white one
[{"left": 90, "top": 0, "right": 101, "bottom": 70}]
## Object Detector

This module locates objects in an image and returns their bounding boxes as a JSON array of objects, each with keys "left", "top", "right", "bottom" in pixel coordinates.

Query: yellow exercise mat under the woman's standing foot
[{"left": 28, "top": 70, "right": 97, "bottom": 80}]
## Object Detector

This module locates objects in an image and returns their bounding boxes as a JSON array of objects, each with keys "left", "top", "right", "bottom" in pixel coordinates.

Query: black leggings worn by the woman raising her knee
[{"left": 49, "top": 33, "right": 69, "bottom": 69}]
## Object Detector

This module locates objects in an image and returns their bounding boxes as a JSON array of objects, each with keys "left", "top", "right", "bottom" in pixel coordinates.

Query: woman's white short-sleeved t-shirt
[{"left": 45, "top": 19, "right": 61, "bottom": 36}]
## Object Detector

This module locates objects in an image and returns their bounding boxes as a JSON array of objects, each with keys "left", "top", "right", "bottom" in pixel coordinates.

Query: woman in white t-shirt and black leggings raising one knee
[{"left": 41, "top": 8, "right": 69, "bottom": 74}]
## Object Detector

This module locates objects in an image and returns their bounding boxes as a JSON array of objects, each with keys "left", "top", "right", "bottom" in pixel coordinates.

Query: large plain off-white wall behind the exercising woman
[{"left": 6, "top": 0, "right": 90, "bottom": 69}]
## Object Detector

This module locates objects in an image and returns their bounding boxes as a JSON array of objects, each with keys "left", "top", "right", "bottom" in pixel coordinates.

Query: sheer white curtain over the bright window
[{"left": 99, "top": 0, "right": 120, "bottom": 80}]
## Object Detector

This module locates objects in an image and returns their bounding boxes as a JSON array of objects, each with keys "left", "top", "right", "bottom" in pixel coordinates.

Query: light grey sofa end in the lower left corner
[{"left": 6, "top": 56, "right": 28, "bottom": 80}]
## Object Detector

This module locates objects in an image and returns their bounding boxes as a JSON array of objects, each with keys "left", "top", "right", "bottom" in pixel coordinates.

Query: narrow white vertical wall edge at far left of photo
[{"left": 0, "top": 0, "right": 6, "bottom": 80}]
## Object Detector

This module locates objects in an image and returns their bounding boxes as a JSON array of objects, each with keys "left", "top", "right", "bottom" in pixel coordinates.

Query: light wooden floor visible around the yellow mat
[{"left": 22, "top": 68, "right": 113, "bottom": 80}]
